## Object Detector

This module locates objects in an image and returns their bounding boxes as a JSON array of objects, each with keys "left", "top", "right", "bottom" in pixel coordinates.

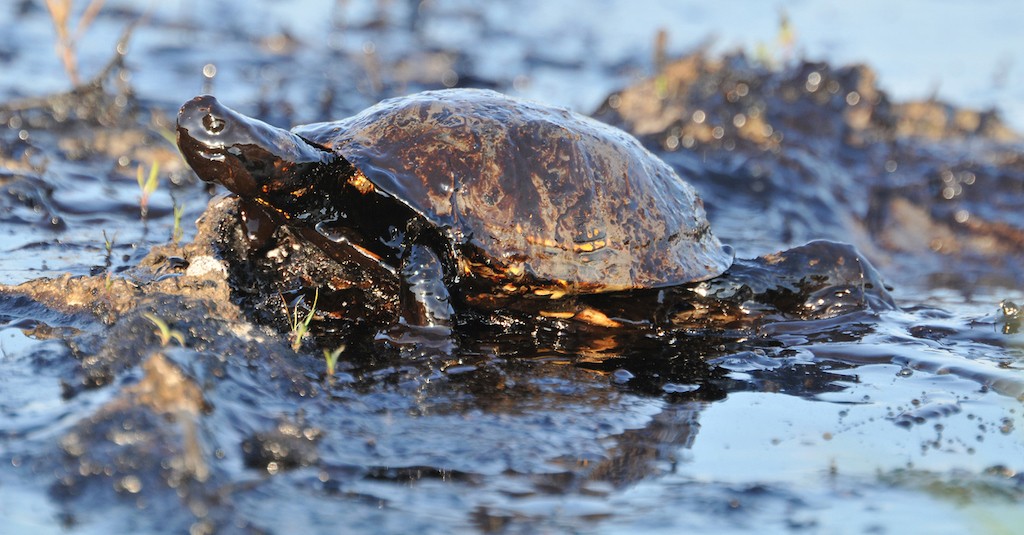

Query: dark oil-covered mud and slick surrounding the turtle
[{"left": 0, "top": 2, "right": 1024, "bottom": 533}]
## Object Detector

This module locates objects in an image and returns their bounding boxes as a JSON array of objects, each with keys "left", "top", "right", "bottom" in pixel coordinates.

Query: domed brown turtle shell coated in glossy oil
[{"left": 293, "top": 89, "right": 732, "bottom": 293}]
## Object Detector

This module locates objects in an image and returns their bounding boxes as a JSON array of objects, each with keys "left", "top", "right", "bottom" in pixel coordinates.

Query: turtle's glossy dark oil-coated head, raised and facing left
[{"left": 178, "top": 95, "right": 337, "bottom": 203}]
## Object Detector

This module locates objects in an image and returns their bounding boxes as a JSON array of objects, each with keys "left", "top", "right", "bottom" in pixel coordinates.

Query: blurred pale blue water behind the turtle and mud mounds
[{"left": 0, "top": 0, "right": 1024, "bottom": 128}]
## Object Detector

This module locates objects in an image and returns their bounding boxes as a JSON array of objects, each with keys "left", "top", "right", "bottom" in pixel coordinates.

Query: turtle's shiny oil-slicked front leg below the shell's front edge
[{"left": 401, "top": 244, "right": 455, "bottom": 329}]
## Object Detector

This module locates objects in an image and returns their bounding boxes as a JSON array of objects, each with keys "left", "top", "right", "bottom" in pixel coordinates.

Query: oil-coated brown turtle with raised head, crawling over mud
[{"left": 177, "top": 88, "right": 733, "bottom": 326}]
